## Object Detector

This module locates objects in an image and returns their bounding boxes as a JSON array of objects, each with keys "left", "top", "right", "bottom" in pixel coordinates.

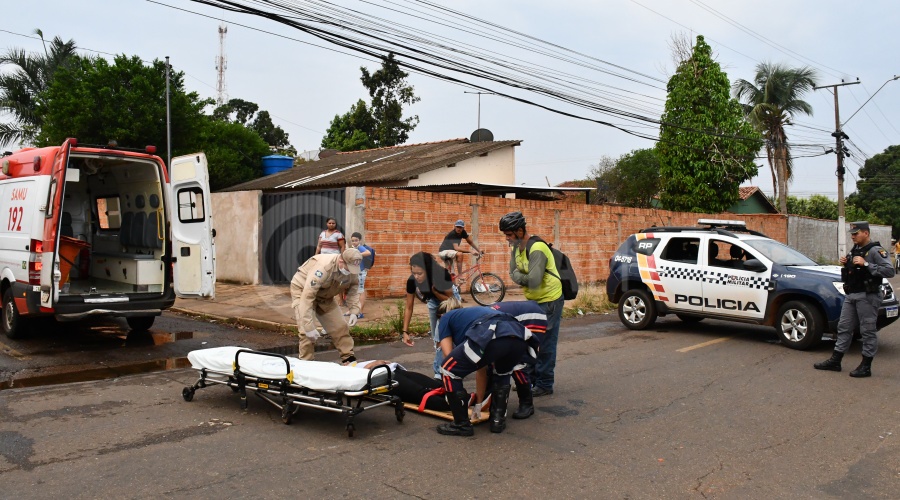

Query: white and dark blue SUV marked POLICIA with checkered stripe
[{"left": 606, "top": 219, "right": 898, "bottom": 349}]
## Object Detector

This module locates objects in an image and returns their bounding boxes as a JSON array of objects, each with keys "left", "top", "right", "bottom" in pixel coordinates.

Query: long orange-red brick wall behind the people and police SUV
[{"left": 364, "top": 187, "right": 787, "bottom": 298}]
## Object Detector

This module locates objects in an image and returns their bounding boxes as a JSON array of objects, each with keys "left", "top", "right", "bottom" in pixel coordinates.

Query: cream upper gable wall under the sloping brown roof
[{"left": 407, "top": 146, "right": 516, "bottom": 186}]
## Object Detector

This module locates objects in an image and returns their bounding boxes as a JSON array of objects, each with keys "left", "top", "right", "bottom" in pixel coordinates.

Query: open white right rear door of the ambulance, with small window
[{"left": 168, "top": 153, "right": 216, "bottom": 299}]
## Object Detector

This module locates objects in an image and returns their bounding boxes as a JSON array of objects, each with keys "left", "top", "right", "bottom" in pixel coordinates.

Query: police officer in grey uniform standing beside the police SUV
[{"left": 813, "top": 221, "right": 894, "bottom": 377}]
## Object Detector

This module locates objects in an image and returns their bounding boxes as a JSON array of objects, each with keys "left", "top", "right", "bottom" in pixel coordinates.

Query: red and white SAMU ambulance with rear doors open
[{"left": 0, "top": 138, "right": 216, "bottom": 338}]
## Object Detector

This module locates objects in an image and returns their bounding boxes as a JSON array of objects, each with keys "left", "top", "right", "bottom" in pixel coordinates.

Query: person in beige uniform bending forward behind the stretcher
[{"left": 291, "top": 248, "right": 362, "bottom": 363}]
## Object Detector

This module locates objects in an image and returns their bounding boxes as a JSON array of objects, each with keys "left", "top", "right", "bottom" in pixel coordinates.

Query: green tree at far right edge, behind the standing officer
[{"left": 847, "top": 145, "right": 900, "bottom": 238}]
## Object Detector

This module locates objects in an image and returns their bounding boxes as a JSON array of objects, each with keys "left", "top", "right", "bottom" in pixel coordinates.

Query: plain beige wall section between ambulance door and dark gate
[{"left": 210, "top": 191, "right": 262, "bottom": 285}]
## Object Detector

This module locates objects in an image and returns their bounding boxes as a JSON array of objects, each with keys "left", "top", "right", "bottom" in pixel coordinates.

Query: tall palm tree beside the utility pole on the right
[{"left": 731, "top": 62, "right": 816, "bottom": 213}]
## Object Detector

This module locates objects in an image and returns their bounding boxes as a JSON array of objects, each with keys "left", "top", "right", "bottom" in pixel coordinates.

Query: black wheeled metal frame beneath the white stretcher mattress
[{"left": 181, "top": 349, "right": 405, "bottom": 437}]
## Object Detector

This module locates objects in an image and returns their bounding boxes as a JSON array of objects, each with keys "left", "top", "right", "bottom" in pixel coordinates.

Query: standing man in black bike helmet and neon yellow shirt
[{"left": 500, "top": 212, "right": 564, "bottom": 397}]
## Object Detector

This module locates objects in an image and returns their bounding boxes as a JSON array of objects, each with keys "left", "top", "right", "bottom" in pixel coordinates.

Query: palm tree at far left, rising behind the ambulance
[{"left": 0, "top": 30, "right": 76, "bottom": 146}]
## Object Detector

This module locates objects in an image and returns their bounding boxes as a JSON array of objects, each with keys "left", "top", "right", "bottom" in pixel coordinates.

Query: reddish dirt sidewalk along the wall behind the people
[{"left": 171, "top": 283, "right": 524, "bottom": 332}]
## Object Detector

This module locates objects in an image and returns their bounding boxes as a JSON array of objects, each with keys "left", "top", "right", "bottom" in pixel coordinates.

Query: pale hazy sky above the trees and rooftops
[{"left": 0, "top": 0, "right": 900, "bottom": 199}]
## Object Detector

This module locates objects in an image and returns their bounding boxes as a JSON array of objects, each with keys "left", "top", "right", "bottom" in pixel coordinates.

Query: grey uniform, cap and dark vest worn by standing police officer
[{"left": 834, "top": 229, "right": 894, "bottom": 358}]
